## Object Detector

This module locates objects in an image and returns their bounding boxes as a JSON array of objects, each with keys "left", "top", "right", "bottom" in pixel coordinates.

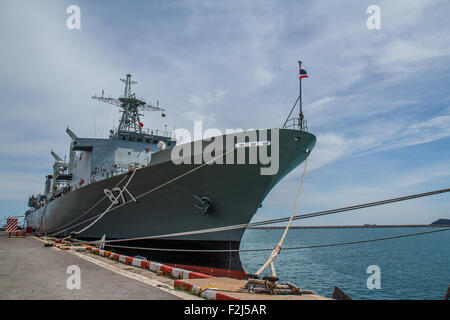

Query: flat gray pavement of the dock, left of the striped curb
[{"left": 0, "top": 232, "right": 182, "bottom": 300}]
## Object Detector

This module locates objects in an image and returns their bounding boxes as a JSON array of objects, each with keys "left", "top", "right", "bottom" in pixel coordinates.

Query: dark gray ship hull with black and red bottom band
[{"left": 26, "top": 129, "right": 316, "bottom": 278}]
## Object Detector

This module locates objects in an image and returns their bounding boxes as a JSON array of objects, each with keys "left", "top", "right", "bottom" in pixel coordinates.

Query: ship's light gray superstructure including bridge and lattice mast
[{"left": 29, "top": 74, "right": 176, "bottom": 208}]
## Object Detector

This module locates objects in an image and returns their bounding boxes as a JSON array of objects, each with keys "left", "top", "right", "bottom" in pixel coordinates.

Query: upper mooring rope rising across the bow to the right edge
[{"left": 99, "top": 188, "right": 450, "bottom": 243}]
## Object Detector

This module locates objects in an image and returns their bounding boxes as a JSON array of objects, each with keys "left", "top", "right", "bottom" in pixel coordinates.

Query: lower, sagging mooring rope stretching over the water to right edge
[{"left": 102, "top": 228, "right": 450, "bottom": 253}]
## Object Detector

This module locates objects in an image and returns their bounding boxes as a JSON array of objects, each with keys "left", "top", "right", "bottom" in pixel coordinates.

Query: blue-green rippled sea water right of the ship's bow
[{"left": 240, "top": 228, "right": 450, "bottom": 300}]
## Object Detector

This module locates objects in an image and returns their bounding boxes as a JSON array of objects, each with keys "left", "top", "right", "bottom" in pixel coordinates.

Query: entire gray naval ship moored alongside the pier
[{"left": 26, "top": 69, "right": 316, "bottom": 279}]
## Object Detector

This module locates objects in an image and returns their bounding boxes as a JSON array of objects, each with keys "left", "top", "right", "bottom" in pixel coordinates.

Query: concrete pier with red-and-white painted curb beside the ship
[{"left": 0, "top": 233, "right": 329, "bottom": 300}]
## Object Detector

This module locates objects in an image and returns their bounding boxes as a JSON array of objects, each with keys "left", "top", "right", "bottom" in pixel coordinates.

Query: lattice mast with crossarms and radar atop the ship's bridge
[{"left": 92, "top": 73, "right": 165, "bottom": 138}]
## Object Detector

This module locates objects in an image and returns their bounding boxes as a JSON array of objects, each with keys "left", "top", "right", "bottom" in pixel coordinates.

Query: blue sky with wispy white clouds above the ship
[{"left": 0, "top": 0, "right": 450, "bottom": 225}]
